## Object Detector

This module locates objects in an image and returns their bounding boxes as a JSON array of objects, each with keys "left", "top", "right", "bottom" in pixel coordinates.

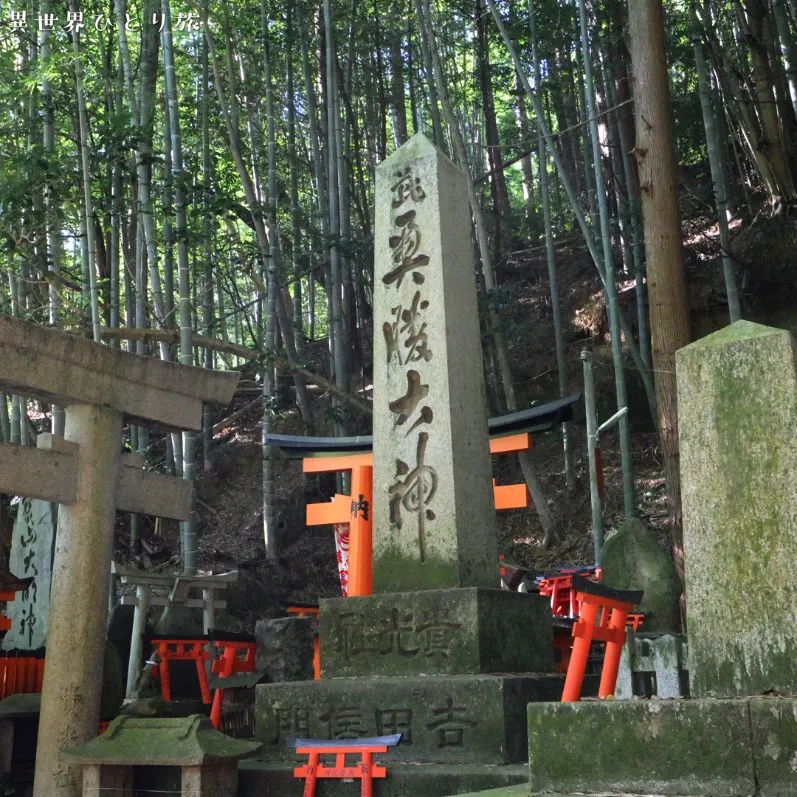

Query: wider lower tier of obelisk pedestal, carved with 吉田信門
[{"left": 255, "top": 675, "right": 562, "bottom": 764}]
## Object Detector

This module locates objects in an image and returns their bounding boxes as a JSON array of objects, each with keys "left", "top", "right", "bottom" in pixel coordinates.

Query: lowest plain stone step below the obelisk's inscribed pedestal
[{"left": 238, "top": 753, "right": 529, "bottom": 797}]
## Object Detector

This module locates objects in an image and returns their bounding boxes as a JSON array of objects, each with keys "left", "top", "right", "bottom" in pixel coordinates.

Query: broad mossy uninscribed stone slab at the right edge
[{"left": 676, "top": 321, "right": 797, "bottom": 697}]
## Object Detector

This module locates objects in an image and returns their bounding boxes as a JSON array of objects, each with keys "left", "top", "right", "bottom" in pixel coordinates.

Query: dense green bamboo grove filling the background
[{"left": 0, "top": 0, "right": 797, "bottom": 573}]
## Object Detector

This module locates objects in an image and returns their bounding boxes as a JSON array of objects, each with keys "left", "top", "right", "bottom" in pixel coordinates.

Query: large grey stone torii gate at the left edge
[{"left": 0, "top": 316, "right": 239, "bottom": 797}]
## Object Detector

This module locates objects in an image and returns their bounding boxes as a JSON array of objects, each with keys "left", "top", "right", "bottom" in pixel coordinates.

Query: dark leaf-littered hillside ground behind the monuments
[{"left": 117, "top": 208, "right": 794, "bottom": 629}]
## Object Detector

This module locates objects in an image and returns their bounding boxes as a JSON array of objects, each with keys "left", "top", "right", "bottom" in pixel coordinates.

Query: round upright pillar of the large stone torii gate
[{"left": 33, "top": 405, "right": 122, "bottom": 797}]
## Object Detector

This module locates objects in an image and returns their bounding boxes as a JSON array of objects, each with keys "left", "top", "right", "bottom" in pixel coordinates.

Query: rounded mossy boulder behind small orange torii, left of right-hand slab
[{"left": 601, "top": 518, "right": 681, "bottom": 631}]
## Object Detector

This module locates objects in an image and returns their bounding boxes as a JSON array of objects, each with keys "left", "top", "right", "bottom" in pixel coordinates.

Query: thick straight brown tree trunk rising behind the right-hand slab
[{"left": 628, "top": 0, "right": 689, "bottom": 577}]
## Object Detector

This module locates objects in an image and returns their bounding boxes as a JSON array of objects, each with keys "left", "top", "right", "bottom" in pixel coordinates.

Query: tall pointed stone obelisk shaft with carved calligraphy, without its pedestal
[{"left": 373, "top": 133, "right": 498, "bottom": 592}]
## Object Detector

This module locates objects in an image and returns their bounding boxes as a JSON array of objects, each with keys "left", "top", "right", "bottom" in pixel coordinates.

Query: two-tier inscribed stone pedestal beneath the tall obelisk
[{"left": 255, "top": 588, "right": 563, "bottom": 765}]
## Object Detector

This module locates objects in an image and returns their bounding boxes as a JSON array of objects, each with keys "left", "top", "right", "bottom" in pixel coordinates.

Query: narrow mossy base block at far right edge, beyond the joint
[{"left": 749, "top": 697, "right": 797, "bottom": 797}]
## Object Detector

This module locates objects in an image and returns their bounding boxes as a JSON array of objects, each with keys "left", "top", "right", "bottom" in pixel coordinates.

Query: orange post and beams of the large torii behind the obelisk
[{"left": 302, "top": 432, "right": 532, "bottom": 597}]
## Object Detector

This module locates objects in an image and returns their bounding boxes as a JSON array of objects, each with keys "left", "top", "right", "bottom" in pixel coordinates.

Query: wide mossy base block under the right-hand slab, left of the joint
[{"left": 528, "top": 700, "right": 756, "bottom": 797}]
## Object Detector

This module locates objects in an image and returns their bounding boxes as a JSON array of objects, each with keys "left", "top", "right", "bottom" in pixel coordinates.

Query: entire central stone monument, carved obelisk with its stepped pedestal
[{"left": 252, "top": 134, "right": 562, "bottom": 795}]
